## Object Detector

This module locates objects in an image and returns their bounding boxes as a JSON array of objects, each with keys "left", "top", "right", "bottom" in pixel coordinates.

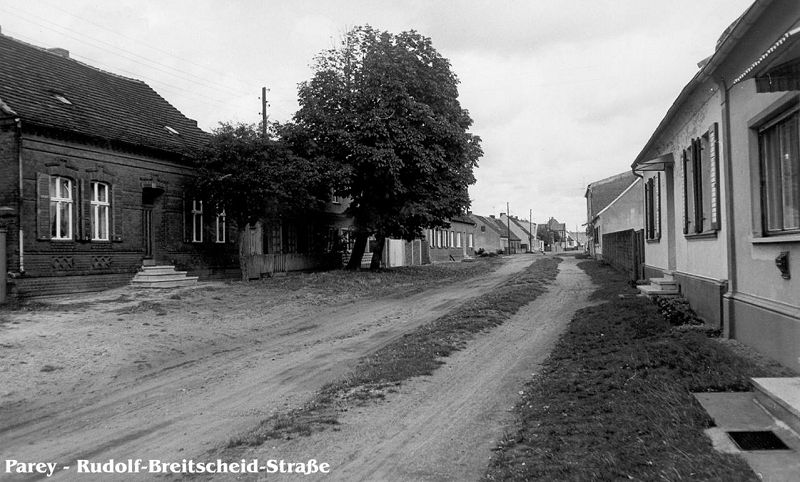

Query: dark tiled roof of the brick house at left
[{"left": 0, "top": 35, "right": 208, "bottom": 158}]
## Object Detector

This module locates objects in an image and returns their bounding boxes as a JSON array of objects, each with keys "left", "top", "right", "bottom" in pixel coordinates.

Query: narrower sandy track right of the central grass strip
[{"left": 241, "top": 257, "right": 595, "bottom": 481}]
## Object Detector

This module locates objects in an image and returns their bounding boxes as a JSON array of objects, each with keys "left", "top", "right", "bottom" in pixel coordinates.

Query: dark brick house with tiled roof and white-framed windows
[{"left": 0, "top": 35, "right": 238, "bottom": 296}]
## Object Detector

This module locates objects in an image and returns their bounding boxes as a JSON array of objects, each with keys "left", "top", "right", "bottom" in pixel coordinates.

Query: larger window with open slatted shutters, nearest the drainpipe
[{"left": 683, "top": 123, "right": 719, "bottom": 235}]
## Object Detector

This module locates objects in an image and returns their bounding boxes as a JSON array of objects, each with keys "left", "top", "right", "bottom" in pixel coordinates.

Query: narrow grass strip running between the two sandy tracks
[{"left": 228, "top": 258, "right": 561, "bottom": 448}]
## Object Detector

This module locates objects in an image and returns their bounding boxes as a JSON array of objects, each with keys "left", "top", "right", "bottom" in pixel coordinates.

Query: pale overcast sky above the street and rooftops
[{"left": 0, "top": 0, "right": 752, "bottom": 230}]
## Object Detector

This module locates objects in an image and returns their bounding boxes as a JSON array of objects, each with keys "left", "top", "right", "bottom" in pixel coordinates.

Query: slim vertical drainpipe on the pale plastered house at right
[{"left": 717, "top": 78, "right": 736, "bottom": 338}]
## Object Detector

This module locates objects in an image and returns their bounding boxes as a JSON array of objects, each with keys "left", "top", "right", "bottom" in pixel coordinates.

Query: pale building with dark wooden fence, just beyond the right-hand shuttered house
[{"left": 586, "top": 172, "right": 644, "bottom": 280}]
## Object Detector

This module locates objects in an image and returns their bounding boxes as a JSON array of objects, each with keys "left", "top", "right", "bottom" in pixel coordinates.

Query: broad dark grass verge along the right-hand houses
[{"left": 485, "top": 261, "right": 792, "bottom": 481}]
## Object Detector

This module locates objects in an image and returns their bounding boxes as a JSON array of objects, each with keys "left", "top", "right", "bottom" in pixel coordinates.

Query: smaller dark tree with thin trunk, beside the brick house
[{"left": 194, "top": 123, "right": 330, "bottom": 277}]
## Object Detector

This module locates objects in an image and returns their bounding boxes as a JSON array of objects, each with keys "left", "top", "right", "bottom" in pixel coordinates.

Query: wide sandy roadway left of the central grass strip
[{"left": 0, "top": 256, "right": 532, "bottom": 480}]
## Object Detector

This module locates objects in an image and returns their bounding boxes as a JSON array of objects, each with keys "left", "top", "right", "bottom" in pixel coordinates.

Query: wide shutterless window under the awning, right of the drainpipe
[{"left": 758, "top": 108, "right": 800, "bottom": 235}]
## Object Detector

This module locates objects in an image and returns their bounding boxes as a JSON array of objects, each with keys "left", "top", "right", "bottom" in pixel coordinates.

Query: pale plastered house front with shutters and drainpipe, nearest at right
[{"left": 632, "top": 0, "right": 800, "bottom": 369}]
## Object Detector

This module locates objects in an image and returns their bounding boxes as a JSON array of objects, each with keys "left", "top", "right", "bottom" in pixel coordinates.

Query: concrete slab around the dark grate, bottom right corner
[{"left": 694, "top": 392, "right": 800, "bottom": 482}]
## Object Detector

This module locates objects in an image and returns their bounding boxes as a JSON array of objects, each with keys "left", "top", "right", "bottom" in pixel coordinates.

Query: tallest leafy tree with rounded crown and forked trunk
[{"left": 294, "top": 26, "right": 482, "bottom": 268}]
